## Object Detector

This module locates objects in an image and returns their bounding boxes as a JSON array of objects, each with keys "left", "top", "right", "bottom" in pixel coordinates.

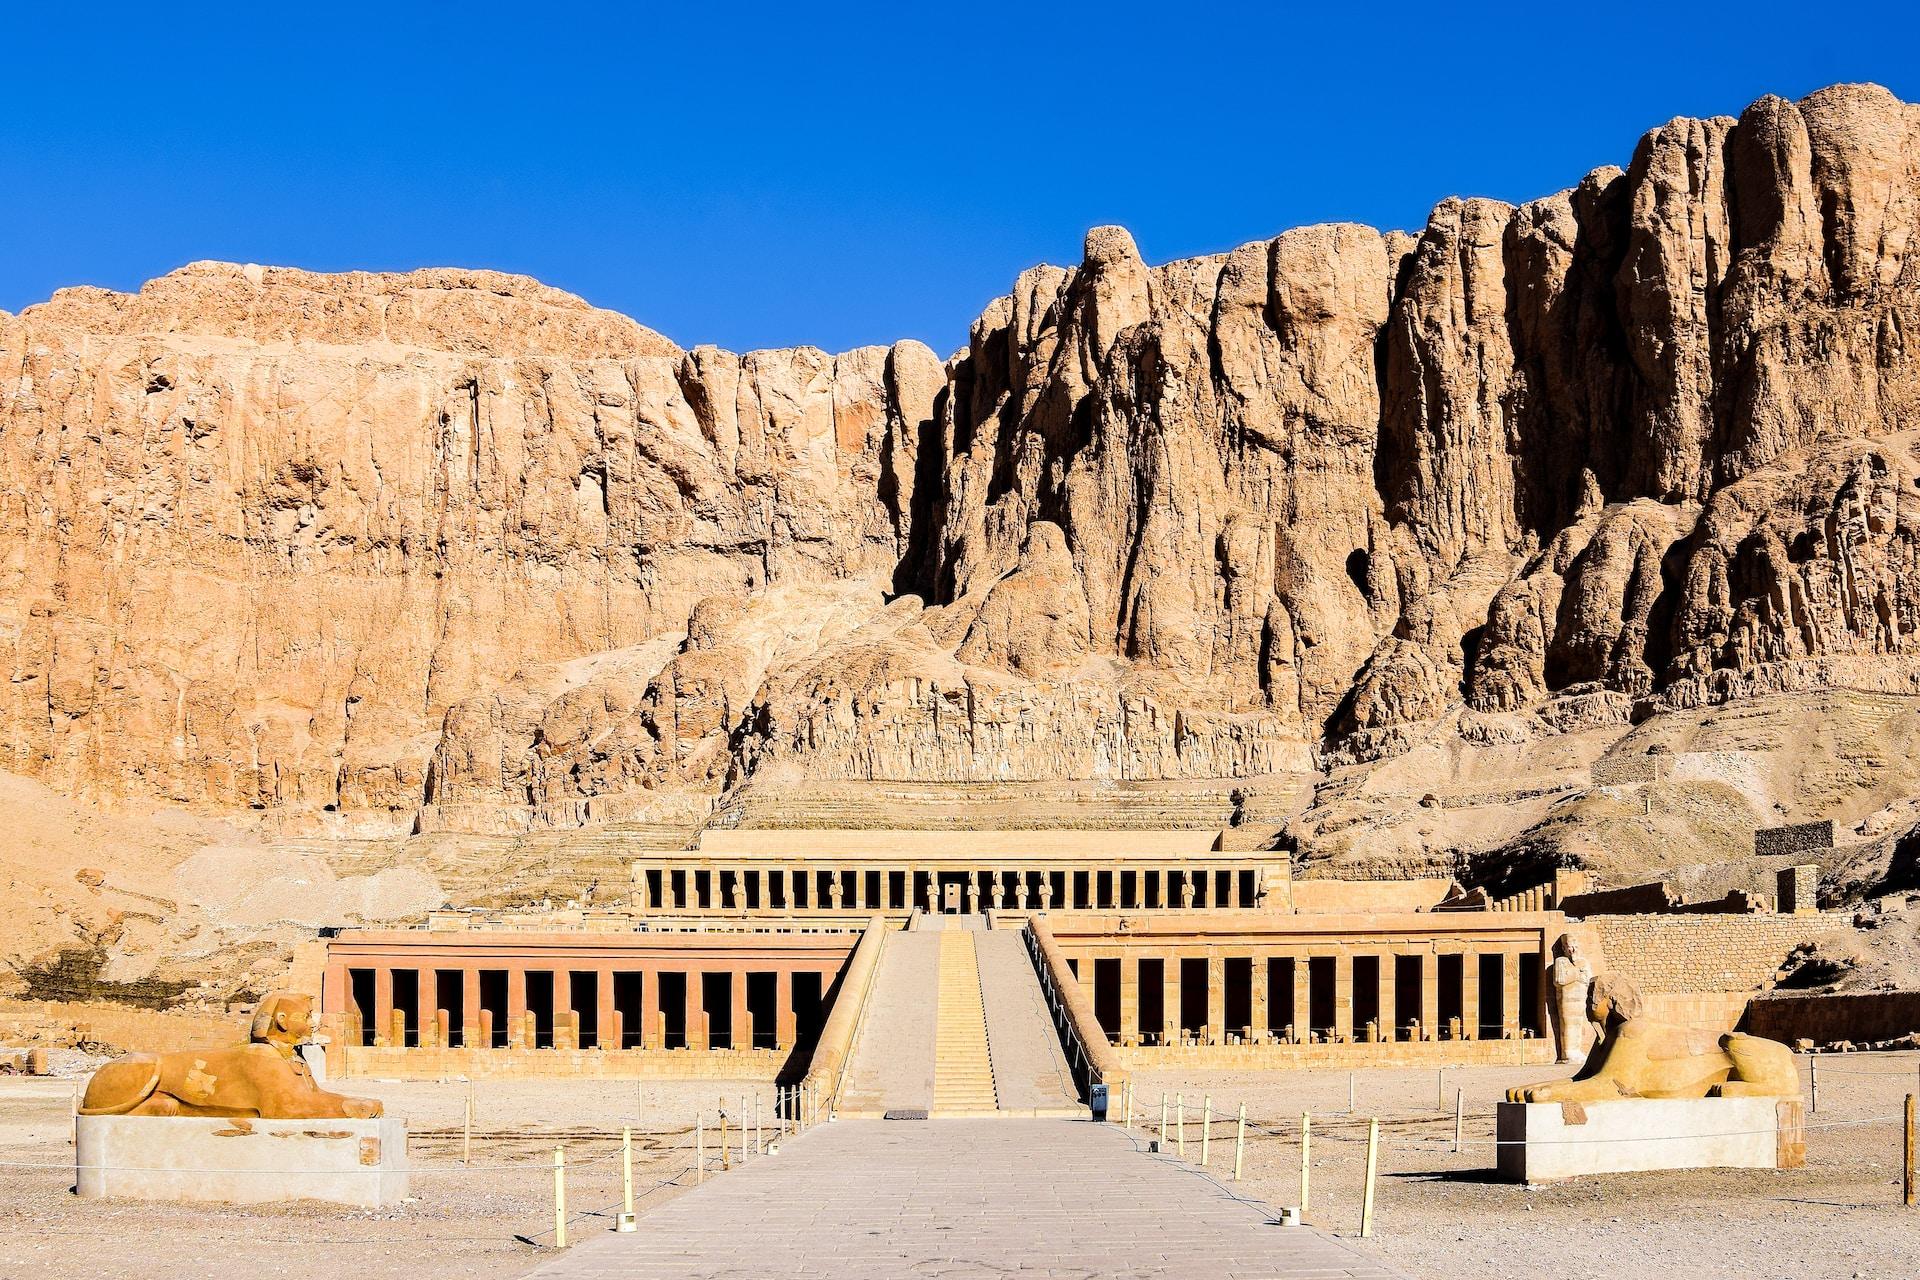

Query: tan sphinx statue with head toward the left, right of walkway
[{"left": 1507, "top": 977, "right": 1801, "bottom": 1102}]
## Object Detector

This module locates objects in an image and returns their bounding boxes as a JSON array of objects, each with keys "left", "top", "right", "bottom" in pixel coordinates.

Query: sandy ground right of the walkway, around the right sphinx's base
[{"left": 1135, "top": 1052, "right": 1920, "bottom": 1280}]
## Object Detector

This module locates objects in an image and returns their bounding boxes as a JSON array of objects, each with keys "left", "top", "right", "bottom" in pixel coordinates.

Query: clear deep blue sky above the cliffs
[{"left": 0, "top": 0, "right": 1920, "bottom": 353}]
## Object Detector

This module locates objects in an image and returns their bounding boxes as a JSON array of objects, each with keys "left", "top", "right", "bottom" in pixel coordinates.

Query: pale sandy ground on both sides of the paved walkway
[{"left": 0, "top": 1054, "right": 1920, "bottom": 1280}]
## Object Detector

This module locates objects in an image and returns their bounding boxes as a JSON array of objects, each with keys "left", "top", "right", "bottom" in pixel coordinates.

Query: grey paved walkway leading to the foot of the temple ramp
[{"left": 534, "top": 1119, "right": 1396, "bottom": 1280}]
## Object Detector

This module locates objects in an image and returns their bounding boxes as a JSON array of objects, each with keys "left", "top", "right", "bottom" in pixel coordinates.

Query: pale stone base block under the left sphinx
[{"left": 73, "top": 1115, "right": 407, "bottom": 1209}]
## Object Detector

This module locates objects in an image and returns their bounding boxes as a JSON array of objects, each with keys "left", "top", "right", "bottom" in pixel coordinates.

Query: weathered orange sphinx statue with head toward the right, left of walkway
[{"left": 81, "top": 992, "right": 380, "bottom": 1121}]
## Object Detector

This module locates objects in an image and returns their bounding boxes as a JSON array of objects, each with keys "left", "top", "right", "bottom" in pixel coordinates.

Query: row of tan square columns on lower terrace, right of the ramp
[{"left": 1073, "top": 948, "right": 1546, "bottom": 1044}]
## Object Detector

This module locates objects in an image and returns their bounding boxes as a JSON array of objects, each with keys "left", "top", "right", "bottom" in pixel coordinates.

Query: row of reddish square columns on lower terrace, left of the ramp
[{"left": 328, "top": 963, "right": 814, "bottom": 1050}]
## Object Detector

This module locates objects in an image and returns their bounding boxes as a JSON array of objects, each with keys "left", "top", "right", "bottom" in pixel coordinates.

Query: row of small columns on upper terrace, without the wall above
[{"left": 634, "top": 864, "right": 1267, "bottom": 912}]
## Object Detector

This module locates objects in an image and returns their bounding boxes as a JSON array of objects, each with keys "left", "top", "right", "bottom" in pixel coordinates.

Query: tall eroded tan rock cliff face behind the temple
[{"left": 0, "top": 86, "right": 1920, "bottom": 829}]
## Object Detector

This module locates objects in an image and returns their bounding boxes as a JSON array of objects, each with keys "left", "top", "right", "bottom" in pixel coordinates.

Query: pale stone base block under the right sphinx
[{"left": 1496, "top": 1098, "right": 1807, "bottom": 1182}]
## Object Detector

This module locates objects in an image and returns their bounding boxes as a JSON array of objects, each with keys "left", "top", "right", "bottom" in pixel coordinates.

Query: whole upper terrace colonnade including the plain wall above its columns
[{"left": 632, "top": 829, "right": 1290, "bottom": 915}]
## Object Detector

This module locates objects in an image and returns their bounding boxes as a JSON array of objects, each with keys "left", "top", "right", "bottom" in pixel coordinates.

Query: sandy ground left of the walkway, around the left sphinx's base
[{"left": 0, "top": 1079, "right": 774, "bottom": 1280}]
